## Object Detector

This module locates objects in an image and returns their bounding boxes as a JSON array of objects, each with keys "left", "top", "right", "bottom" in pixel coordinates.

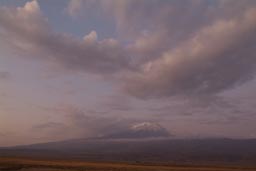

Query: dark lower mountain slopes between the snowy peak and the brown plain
[{"left": 0, "top": 138, "right": 256, "bottom": 165}]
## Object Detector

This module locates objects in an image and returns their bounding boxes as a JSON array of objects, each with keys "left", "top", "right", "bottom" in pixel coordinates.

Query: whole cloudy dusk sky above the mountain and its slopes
[{"left": 0, "top": 0, "right": 256, "bottom": 146}]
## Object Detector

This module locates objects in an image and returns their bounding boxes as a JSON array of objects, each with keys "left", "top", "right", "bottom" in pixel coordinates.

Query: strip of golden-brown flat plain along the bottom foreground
[{"left": 0, "top": 158, "right": 256, "bottom": 171}]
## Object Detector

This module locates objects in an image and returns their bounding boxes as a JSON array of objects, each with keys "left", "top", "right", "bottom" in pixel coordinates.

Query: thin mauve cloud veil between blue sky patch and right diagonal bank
[{"left": 95, "top": 0, "right": 218, "bottom": 63}]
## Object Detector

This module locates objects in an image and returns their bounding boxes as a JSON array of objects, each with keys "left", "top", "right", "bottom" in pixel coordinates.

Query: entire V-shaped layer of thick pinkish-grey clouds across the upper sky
[{"left": 0, "top": 0, "right": 256, "bottom": 98}]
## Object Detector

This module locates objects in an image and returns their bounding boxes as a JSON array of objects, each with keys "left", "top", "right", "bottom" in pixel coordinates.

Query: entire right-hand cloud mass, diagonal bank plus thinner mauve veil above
[{"left": 68, "top": 0, "right": 255, "bottom": 98}]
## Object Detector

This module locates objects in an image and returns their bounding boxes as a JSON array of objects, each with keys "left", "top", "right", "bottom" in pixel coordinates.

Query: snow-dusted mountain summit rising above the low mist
[{"left": 103, "top": 122, "right": 170, "bottom": 139}]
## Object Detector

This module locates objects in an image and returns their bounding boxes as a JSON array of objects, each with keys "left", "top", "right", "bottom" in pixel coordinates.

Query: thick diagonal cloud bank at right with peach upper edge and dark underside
[{"left": 124, "top": 8, "right": 256, "bottom": 98}]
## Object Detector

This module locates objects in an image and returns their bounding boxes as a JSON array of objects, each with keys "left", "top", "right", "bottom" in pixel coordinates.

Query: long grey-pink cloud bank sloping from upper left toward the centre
[{"left": 0, "top": 0, "right": 130, "bottom": 74}]
